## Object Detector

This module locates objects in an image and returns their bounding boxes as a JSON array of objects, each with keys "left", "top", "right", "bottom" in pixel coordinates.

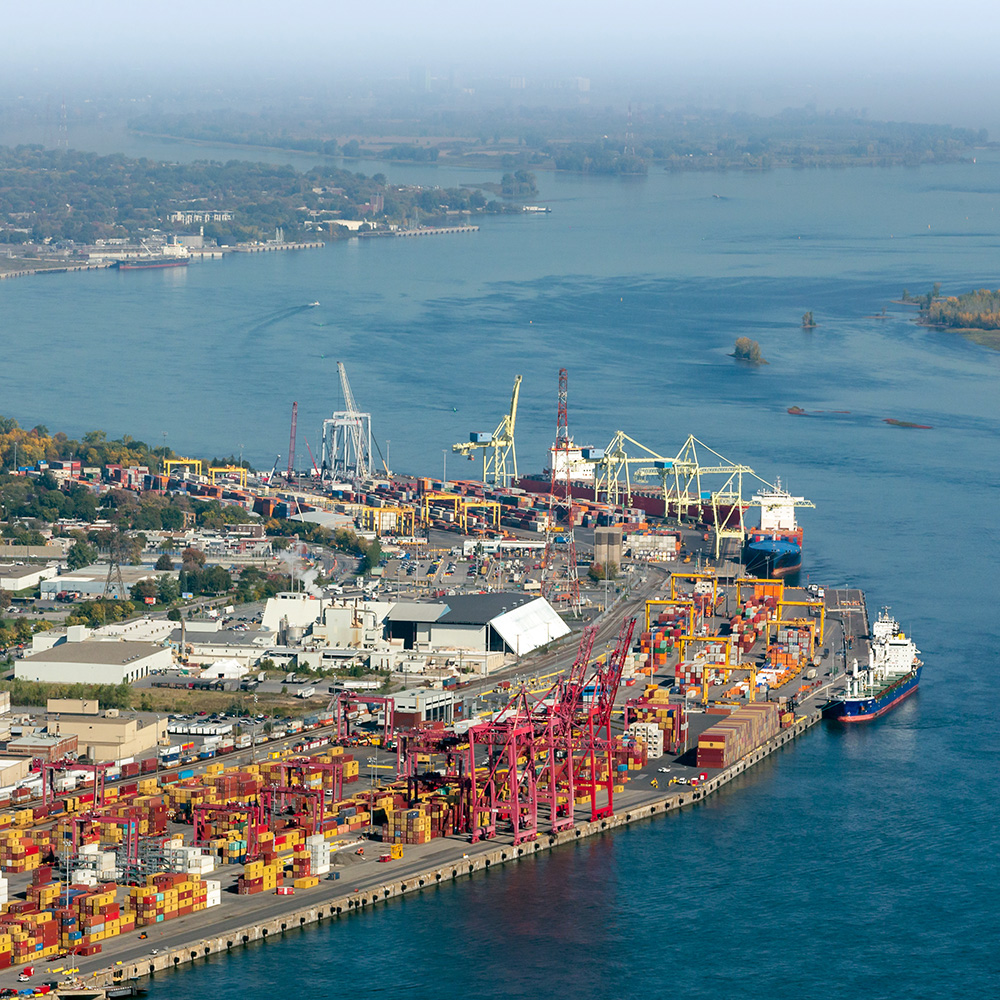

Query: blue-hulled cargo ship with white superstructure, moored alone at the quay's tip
[{"left": 823, "top": 608, "right": 924, "bottom": 722}]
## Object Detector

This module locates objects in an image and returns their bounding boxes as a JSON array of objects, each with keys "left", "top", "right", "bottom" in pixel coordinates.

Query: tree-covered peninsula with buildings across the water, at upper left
[{"left": 0, "top": 146, "right": 535, "bottom": 244}]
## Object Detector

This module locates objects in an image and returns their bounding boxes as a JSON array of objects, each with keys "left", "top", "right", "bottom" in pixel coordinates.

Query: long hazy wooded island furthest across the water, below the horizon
[{"left": 129, "top": 104, "right": 988, "bottom": 174}]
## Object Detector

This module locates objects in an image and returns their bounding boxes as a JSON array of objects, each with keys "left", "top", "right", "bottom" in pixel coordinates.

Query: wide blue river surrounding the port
[{"left": 0, "top": 149, "right": 1000, "bottom": 1000}]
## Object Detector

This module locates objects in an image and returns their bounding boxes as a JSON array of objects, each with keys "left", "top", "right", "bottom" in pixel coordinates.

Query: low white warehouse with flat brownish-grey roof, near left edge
[{"left": 14, "top": 625, "right": 173, "bottom": 684}]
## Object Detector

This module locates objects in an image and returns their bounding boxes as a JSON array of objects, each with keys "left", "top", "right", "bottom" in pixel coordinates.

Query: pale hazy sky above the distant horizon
[{"left": 0, "top": 0, "right": 998, "bottom": 124}]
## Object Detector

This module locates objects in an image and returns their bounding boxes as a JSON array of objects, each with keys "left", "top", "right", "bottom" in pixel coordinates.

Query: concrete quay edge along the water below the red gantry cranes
[{"left": 86, "top": 712, "right": 821, "bottom": 986}]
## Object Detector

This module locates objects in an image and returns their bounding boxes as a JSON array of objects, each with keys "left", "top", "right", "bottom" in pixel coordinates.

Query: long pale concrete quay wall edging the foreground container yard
[{"left": 77, "top": 712, "right": 829, "bottom": 987}]
